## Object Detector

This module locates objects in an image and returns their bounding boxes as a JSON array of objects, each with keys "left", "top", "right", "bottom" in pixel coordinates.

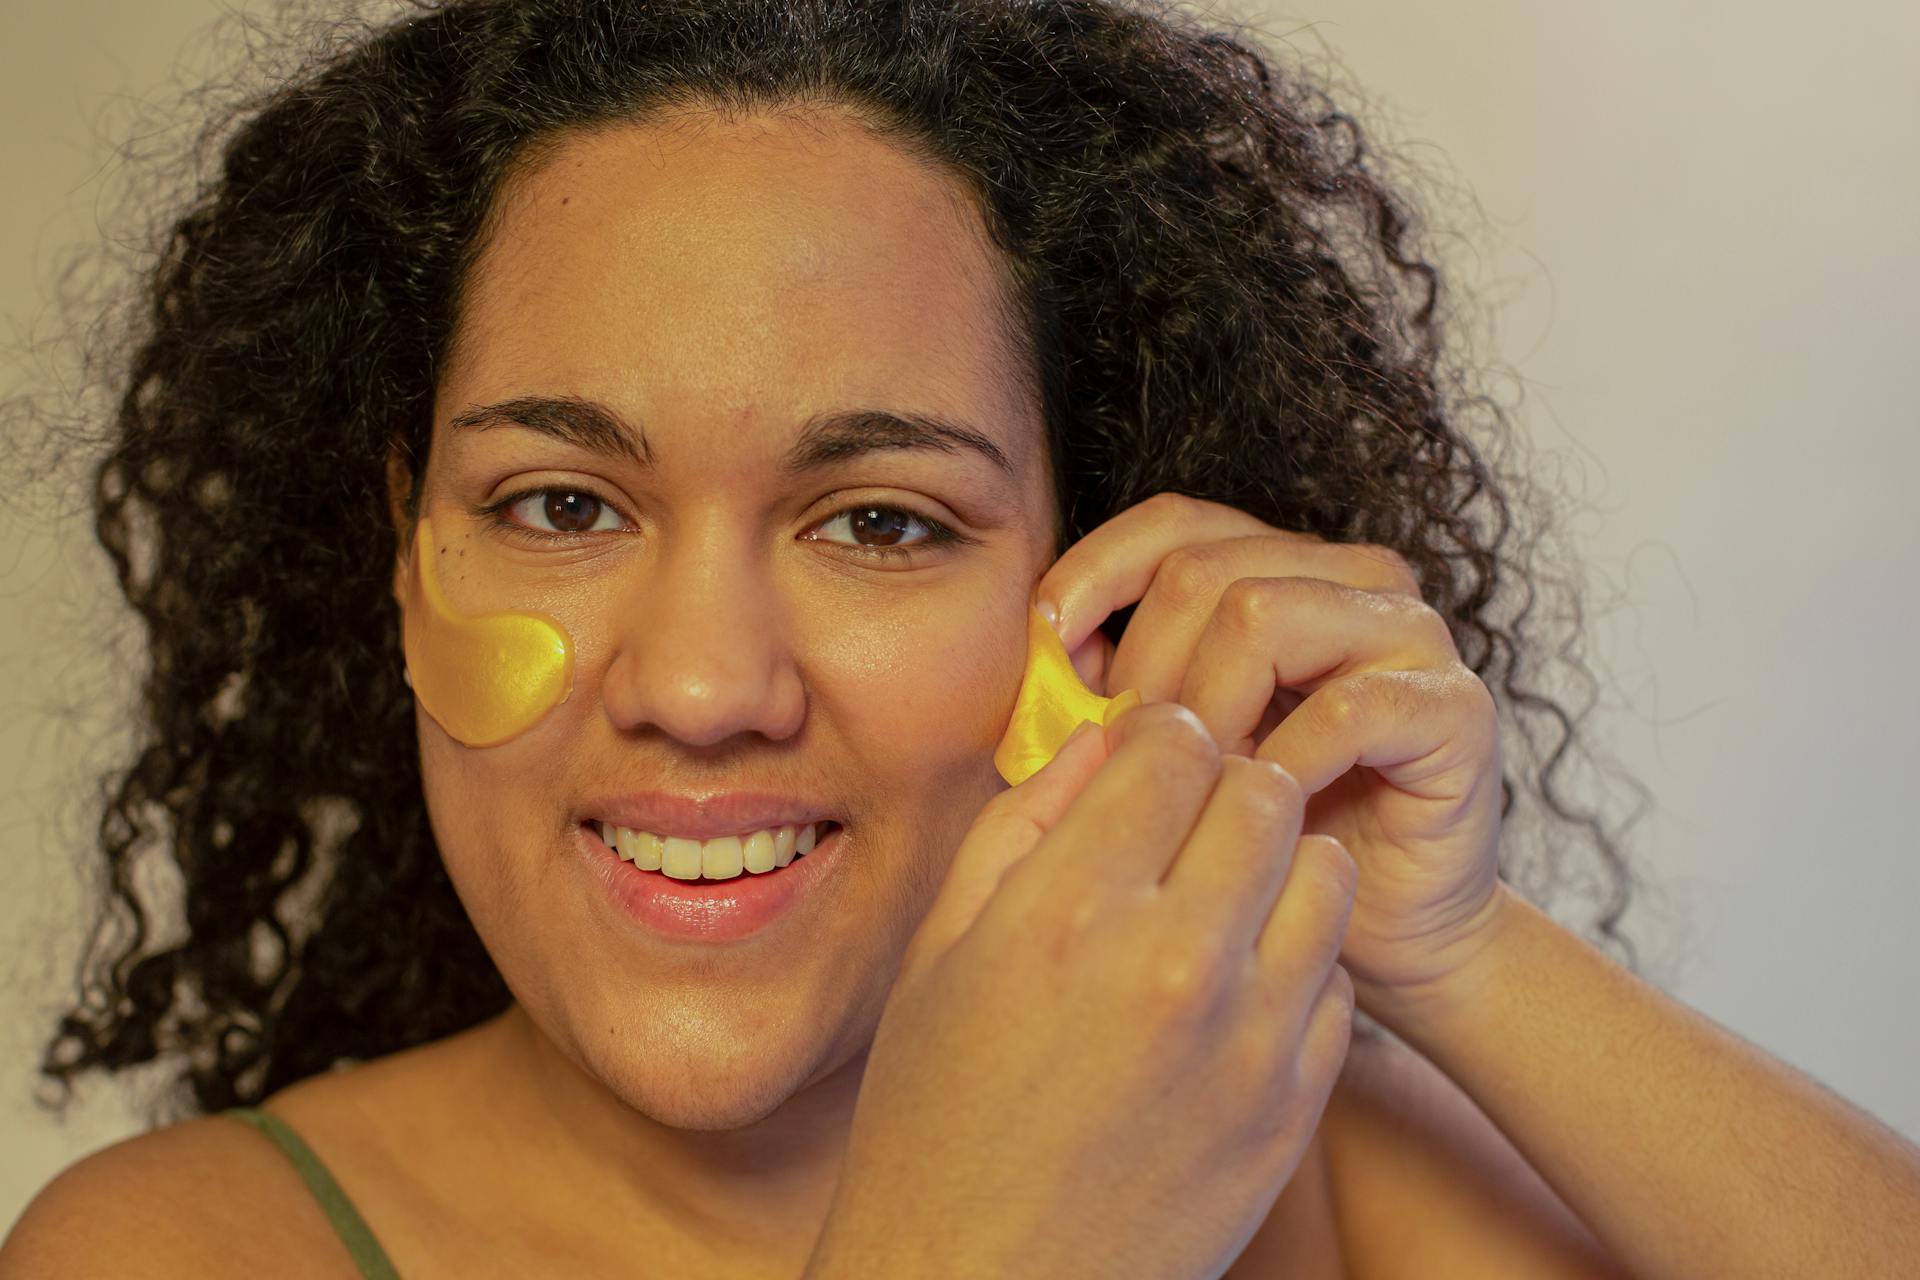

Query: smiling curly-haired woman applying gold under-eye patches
[{"left": 11, "top": 0, "right": 1920, "bottom": 1278}]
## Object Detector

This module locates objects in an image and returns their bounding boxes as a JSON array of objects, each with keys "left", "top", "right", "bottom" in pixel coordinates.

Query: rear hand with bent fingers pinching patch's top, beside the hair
[{"left": 1033, "top": 493, "right": 1501, "bottom": 1011}]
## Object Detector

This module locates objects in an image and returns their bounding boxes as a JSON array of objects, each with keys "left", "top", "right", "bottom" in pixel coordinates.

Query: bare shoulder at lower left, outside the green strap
[{"left": 0, "top": 1115, "right": 351, "bottom": 1280}]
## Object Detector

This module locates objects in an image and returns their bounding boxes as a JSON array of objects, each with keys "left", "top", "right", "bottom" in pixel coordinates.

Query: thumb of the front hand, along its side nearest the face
[{"left": 902, "top": 720, "right": 1108, "bottom": 969}]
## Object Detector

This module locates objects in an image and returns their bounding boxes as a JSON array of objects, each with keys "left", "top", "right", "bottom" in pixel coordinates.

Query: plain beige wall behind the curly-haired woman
[{"left": 0, "top": 0, "right": 1920, "bottom": 1222}]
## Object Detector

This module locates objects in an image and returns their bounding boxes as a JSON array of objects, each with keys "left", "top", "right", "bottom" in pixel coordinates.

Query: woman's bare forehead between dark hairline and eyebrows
[{"left": 436, "top": 117, "right": 1039, "bottom": 485}]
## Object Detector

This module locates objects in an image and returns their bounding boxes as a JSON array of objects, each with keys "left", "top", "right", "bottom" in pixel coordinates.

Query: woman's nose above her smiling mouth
[{"left": 601, "top": 553, "right": 806, "bottom": 747}]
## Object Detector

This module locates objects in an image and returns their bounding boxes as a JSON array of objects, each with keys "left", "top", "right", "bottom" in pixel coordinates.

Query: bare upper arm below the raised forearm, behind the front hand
[{"left": 1321, "top": 1025, "right": 1628, "bottom": 1280}]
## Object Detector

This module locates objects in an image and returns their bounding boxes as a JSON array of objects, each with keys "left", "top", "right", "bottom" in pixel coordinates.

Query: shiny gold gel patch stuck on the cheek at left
[{"left": 401, "top": 520, "right": 574, "bottom": 747}]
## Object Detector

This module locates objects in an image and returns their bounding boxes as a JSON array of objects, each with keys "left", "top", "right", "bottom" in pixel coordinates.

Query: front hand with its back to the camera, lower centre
[{"left": 806, "top": 702, "right": 1357, "bottom": 1280}]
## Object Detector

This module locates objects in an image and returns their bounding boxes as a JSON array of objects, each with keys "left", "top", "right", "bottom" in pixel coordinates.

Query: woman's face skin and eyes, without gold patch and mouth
[{"left": 396, "top": 113, "right": 1054, "bottom": 1128}]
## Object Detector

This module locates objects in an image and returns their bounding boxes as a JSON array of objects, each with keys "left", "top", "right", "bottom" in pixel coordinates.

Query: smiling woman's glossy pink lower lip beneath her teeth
[{"left": 576, "top": 823, "right": 845, "bottom": 942}]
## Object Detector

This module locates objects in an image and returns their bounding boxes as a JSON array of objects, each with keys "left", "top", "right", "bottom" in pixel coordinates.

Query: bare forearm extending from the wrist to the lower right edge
[{"left": 1363, "top": 887, "right": 1920, "bottom": 1280}]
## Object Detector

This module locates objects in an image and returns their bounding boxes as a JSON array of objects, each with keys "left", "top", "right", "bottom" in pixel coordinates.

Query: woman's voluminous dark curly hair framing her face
[{"left": 15, "top": 0, "right": 1640, "bottom": 1117}]
